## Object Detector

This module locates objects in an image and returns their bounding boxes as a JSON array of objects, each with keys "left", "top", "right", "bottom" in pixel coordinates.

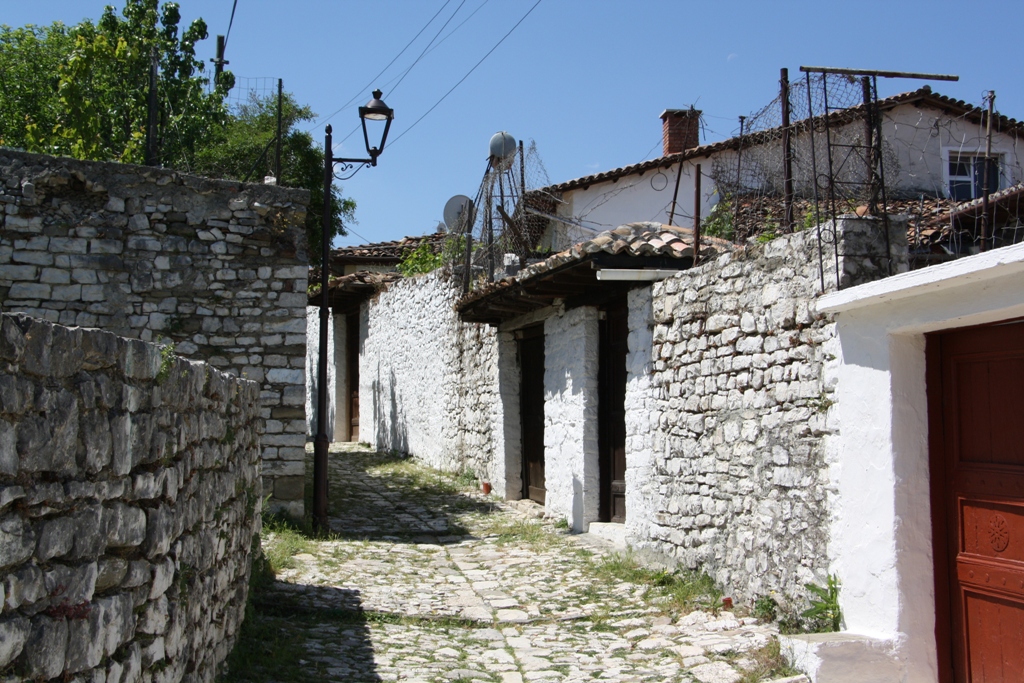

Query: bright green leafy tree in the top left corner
[{"left": 0, "top": 0, "right": 233, "bottom": 165}]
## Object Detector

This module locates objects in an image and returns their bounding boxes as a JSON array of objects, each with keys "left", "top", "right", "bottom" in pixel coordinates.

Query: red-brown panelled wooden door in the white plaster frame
[{"left": 928, "top": 322, "right": 1024, "bottom": 683}]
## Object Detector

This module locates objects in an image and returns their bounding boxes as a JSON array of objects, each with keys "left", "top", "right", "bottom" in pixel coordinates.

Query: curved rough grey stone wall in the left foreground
[{"left": 0, "top": 313, "right": 262, "bottom": 683}]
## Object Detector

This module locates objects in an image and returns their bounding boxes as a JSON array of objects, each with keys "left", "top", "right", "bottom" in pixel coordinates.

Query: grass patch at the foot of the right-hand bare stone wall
[{"left": 593, "top": 553, "right": 722, "bottom": 612}]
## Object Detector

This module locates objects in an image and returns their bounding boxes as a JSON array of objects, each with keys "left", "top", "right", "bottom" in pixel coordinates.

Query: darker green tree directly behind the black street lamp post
[{"left": 195, "top": 93, "right": 355, "bottom": 264}]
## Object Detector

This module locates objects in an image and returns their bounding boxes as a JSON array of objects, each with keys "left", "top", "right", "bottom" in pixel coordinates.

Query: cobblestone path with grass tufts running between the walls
[{"left": 220, "top": 445, "right": 806, "bottom": 683}]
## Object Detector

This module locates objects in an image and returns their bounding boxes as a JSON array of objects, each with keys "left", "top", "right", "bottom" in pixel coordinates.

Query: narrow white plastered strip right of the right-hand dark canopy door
[{"left": 626, "top": 287, "right": 666, "bottom": 539}]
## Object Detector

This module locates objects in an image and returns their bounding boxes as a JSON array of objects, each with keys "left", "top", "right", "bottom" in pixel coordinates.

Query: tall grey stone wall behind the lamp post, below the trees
[{"left": 0, "top": 150, "right": 309, "bottom": 515}]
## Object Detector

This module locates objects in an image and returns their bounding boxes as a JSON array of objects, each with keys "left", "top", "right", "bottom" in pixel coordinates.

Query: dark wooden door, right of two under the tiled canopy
[{"left": 597, "top": 298, "right": 629, "bottom": 523}]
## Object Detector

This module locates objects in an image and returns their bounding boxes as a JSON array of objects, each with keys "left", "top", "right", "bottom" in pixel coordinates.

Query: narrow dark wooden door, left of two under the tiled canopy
[{"left": 519, "top": 326, "right": 547, "bottom": 505}]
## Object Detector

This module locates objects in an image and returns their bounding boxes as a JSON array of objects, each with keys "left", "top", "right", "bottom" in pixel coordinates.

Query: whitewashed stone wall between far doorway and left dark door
[{"left": 359, "top": 270, "right": 504, "bottom": 481}]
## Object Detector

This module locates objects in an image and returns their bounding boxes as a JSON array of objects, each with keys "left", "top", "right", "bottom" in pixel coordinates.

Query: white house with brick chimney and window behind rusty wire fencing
[{"left": 537, "top": 86, "right": 1024, "bottom": 251}]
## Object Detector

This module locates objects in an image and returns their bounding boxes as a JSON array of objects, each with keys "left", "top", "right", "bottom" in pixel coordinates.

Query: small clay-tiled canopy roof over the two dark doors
[{"left": 457, "top": 222, "right": 733, "bottom": 310}]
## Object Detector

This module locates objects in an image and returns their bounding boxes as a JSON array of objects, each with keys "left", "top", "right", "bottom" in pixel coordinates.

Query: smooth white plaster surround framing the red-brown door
[{"left": 818, "top": 240, "right": 1024, "bottom": 682}]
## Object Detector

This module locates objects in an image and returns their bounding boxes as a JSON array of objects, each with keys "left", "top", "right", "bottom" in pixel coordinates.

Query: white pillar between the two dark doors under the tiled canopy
[{"left": 544, "top": 306, "right": 600, "bottom": 531}]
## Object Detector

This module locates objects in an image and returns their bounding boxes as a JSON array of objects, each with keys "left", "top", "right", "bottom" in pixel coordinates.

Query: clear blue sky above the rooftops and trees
[{"left": 8, "top": 0, "right": 1024, "bottom": 245}]
